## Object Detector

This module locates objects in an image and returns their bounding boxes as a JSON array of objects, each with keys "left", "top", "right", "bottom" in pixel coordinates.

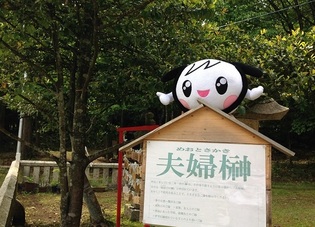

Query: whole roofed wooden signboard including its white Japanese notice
[{"left": 120, "top": 105, "right": 294, "bottom": 227}]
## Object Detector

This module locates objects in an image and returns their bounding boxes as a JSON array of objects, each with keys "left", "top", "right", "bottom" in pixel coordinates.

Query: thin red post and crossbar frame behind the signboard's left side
[{"left": 116, "top": 125, "right": 159, "bottom": 227}]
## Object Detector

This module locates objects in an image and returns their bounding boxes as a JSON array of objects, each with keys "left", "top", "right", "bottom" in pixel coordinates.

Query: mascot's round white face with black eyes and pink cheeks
[{"left": 176, "top": 60, "right": 244, "bottom": 110}]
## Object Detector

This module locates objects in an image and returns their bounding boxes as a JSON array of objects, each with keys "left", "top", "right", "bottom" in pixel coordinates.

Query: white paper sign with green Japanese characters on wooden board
[{"left": 143, "top": 141, "right": 266, "bottom": 227}]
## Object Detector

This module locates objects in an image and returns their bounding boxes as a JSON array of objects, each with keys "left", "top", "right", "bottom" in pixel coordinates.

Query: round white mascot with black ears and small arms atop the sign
[{"left": 156, "top": 59, "right": 264, "bottom": 113}]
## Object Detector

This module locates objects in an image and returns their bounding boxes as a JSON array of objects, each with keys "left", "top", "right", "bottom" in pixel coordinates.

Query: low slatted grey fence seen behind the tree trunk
[{"left": 19, "top": 160, "right": 118, "bottom": 188}]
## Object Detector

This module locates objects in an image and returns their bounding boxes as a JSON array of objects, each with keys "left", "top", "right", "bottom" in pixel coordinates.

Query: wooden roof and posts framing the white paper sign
[{"left": 120, "top": 104, "right": 294, "bottom": 226}]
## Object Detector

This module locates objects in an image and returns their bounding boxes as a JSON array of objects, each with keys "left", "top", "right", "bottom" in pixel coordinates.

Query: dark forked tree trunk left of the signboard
[{"left": 50, "top": 1, "right": 105, "bottom": 227}]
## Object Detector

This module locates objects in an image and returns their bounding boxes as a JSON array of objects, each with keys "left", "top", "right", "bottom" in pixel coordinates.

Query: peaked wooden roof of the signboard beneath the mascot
[{"left": 120, "top": 104, "right": 295, "bottom": 156}]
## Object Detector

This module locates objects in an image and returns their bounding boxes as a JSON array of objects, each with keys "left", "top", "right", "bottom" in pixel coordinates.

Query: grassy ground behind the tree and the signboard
[{"left": 0, "top": 161, "right": 315, "bottom": 227}]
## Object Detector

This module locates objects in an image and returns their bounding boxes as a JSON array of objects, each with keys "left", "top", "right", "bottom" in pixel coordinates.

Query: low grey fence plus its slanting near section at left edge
[{"left": 0, "top": 160, "right": 118, "bottom": 227}]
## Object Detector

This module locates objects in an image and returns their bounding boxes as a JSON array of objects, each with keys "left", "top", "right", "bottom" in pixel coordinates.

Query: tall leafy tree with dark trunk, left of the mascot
[{"left": 0, "top": 0, "right": 217, "bottom": 226}]
